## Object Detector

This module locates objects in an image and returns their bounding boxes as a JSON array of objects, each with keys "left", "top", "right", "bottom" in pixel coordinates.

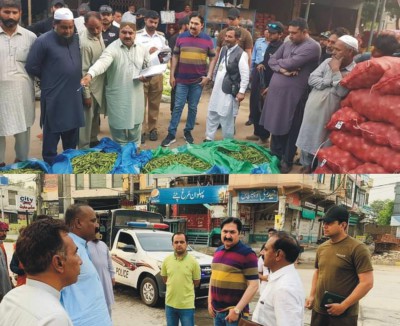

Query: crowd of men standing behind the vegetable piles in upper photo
[{"left": 0, "top": 0, "right": 399, "bottom": 169}]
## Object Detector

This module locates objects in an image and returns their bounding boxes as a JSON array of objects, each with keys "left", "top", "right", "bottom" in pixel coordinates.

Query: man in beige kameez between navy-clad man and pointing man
[{"left": 78, "top": 11, "right": 106, "bottom": 148}]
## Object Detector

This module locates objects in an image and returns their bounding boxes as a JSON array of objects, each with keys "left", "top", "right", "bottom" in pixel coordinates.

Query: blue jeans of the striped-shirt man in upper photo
[{"left": 168, "top": 83, "right": 203, "bottom": 136}]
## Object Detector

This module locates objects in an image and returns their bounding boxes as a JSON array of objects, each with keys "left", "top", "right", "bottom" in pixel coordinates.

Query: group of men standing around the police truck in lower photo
[{"left": 0, "top": 204, "right": 373, "bottom": 326}]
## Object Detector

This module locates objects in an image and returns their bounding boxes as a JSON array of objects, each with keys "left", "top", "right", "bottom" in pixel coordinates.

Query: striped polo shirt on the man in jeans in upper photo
[{"left": 174, "top": 31, "right": 215, "bottom": 84}]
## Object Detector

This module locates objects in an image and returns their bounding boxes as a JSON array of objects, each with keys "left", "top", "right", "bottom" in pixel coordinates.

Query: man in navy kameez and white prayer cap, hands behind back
[{"left": 25, "top": 8, "right": 84, "bottom": 164}]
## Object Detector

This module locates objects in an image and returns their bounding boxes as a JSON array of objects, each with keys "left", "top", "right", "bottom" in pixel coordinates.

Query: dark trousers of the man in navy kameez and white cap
[{"left": 42, "top": 126, "right": 79, "bottom": 164}]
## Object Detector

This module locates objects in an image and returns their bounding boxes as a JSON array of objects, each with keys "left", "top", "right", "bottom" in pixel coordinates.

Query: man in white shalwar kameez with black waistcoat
[{"left": 206, "top": 27, "right": 250, "bottom": 141}]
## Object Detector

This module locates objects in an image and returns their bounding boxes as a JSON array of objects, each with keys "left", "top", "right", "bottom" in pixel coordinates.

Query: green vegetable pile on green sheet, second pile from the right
[{"left": 141, "top": 153, "right": 211, "bottom": 173}]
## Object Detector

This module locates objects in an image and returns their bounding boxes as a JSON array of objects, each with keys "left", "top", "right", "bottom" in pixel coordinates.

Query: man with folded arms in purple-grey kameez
[{"left": 260, "top": 18, "right": 321, "bottom": 173}]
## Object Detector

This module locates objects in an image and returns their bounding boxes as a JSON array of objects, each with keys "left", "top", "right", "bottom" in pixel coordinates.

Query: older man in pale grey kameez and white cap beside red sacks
[{"left": 296, "top": 35, "right": 358, "bottom": 173}]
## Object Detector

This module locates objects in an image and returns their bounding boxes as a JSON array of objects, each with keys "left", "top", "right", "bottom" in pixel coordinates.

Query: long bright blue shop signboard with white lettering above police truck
[{"left": 150, "top": 186, "right": 228, "bottom": 205}]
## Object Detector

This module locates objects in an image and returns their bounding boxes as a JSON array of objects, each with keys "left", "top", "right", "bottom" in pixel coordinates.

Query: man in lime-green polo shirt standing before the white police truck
[{"left": 161, "top": 232, "right": 201, "bottom": 326}]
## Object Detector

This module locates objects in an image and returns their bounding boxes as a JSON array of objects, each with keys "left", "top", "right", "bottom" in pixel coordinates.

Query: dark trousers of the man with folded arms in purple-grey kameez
[{"left": 271, "top": 90, "right": 308, "bottom": 166}]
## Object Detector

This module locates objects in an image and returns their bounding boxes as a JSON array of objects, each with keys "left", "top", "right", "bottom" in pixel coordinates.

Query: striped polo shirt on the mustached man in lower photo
[{"left": 210, "top": 241, "right": 258, "bottom": 313}]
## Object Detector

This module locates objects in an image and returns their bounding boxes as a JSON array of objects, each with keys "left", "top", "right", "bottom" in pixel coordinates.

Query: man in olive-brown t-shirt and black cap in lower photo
[{"left": 306, "top": 206, "right": 374, "bottom": 326}]
